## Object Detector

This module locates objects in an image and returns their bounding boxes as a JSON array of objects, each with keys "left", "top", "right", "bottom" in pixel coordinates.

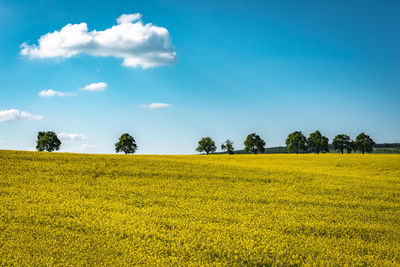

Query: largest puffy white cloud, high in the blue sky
[{"left": 20, "top": 13, "right": 176, "bottom": 69}]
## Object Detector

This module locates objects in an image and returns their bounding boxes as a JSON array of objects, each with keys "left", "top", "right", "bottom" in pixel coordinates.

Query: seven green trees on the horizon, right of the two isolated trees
[{"left": 196, "top": 130, "right": 375, "bottom": 155}]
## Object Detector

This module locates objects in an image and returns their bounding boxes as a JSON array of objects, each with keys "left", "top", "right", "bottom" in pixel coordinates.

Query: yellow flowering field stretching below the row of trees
[{"left": 0, "top": 151, "right": 400, "bottom": 266}]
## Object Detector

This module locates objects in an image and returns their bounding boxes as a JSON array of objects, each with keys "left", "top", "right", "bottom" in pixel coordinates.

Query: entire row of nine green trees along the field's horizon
[{"left": 36, "top": 130, "right": 375, "bottom": 155}]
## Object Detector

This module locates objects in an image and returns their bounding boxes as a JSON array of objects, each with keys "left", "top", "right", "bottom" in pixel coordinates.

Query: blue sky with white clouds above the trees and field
[{"left": 0, "top": 0, "right": 400, "bottom": 154}]
